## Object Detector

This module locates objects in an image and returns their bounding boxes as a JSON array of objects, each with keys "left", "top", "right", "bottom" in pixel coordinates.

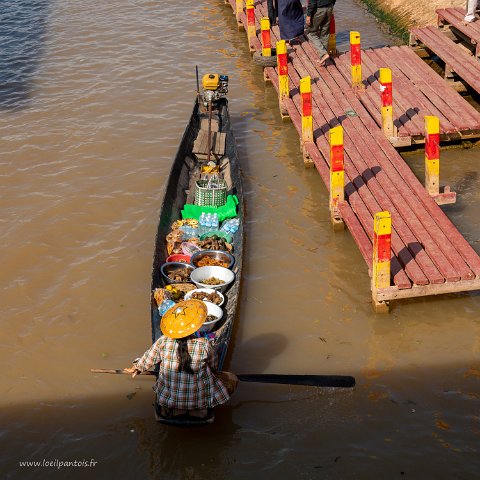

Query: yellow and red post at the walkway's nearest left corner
[{"left": 372, "top": 211, "right": 392, "bottom": 313}]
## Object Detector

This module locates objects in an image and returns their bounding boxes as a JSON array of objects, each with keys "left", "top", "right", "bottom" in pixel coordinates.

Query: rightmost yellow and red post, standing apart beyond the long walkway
[{"left": 425, "top": 116, "right": 440, "bottom": 196}]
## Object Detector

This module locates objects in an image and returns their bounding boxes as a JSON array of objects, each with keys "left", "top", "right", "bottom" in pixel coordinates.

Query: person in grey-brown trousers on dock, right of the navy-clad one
[{"left": 305, "top": 0, "right": 335, "bottom": 65}]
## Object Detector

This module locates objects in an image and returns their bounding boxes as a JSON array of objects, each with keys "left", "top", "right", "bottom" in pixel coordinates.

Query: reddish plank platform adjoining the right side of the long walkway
[{"left": 336, "top": 46, "right": 480, "bottom": 146}]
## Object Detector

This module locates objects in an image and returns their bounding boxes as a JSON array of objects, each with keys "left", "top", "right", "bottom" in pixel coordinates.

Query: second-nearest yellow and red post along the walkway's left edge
[{"left": 329, "top": 125, "right": 345, "bottom": 230}]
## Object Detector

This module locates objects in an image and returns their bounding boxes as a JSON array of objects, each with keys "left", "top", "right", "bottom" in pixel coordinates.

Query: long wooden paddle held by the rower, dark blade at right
[{"left": 90, "top": 368, "right": 355, "bottom": 388}]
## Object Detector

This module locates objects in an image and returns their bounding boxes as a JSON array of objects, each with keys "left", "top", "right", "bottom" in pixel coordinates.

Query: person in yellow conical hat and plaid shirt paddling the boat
[{"left": 126, "top": 300, "right": 238, "bottom": 417}]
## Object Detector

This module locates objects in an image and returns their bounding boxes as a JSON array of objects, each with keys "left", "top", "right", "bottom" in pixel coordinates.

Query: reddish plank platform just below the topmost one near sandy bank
[{"left": 410, "top": 26, "right": 480, "bottom": 93}]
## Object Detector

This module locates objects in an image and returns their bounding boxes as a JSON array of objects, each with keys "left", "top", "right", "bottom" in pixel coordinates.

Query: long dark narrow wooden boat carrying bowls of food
[{"left": 151, "top": 97, "right": 244, "bottom": 426}]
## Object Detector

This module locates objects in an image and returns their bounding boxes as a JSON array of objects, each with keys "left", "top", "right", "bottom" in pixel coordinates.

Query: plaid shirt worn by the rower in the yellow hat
[{"left": 136, "top": 336, "right": 230, "bottom": 410}]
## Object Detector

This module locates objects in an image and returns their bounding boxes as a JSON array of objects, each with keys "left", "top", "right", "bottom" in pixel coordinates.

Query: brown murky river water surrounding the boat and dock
[{"left": 0, "top": 0, "right": 480, "bottom": 480}]
